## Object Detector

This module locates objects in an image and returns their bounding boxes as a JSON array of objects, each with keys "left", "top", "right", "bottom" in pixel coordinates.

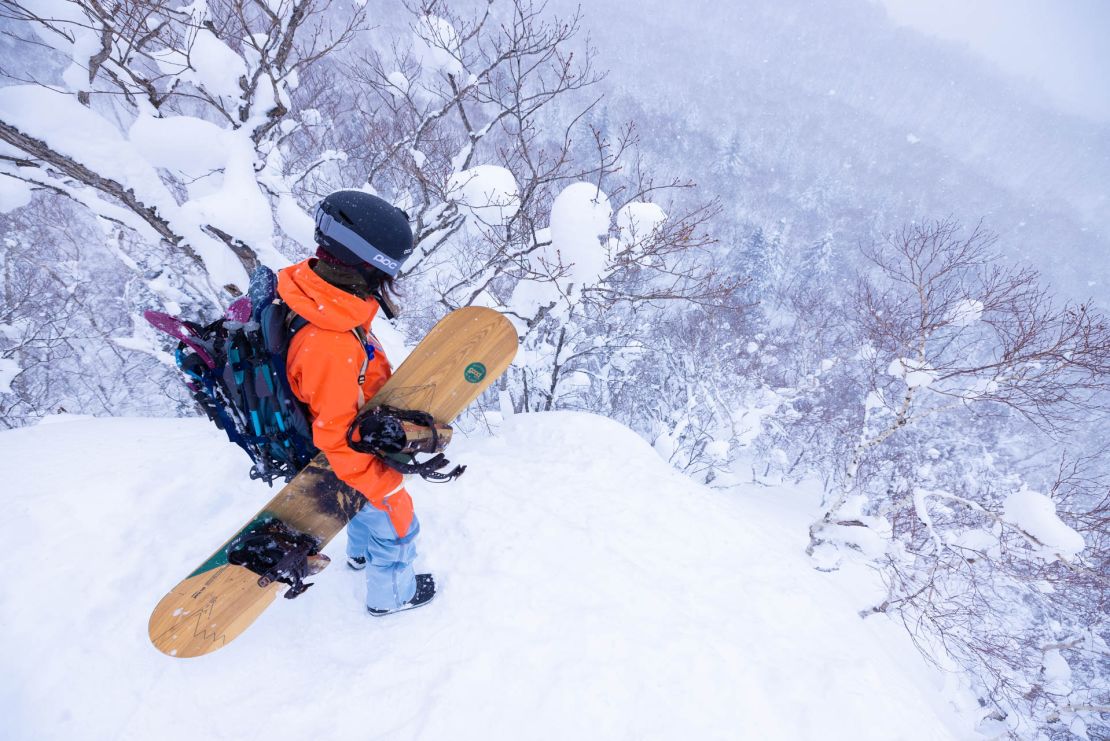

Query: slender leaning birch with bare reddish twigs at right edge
[{"left": 811, "top": 221, "right": 1110, "bottom": 550}]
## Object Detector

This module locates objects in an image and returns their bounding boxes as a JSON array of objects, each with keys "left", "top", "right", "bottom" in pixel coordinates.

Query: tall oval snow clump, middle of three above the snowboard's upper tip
[{"left": 547, "top": 183, "right": 613, "bottom": 288}]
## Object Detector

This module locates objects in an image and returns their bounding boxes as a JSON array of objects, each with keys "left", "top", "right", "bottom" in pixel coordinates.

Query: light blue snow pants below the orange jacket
[{"left": 347, "top": 503, "right": 420, "bottom": 610}]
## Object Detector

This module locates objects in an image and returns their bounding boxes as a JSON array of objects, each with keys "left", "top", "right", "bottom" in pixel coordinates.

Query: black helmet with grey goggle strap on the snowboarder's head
[{"left": 316, "top": 191, "right": 413, "bottom": 277}]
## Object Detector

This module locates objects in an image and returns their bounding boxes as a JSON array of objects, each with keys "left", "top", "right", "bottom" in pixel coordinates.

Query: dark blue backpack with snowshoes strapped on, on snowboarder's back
[{"left": 143, "top": 266, "right": 319, "bottom": 486}]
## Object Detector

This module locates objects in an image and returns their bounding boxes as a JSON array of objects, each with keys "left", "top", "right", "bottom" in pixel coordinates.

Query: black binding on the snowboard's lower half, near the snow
[{"left": 228, "top": 518, "right": 330, "bottom": 599}]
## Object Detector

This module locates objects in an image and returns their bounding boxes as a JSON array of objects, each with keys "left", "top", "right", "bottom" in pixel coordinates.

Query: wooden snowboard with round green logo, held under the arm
[{"left": 148, "top": 306, "right": 517, "bottom": 658}]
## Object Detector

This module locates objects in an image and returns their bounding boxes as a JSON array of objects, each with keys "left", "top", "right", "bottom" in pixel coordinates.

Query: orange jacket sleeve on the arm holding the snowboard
[{"left": 289, "top": 326, "right": 404, "bottom": 507}]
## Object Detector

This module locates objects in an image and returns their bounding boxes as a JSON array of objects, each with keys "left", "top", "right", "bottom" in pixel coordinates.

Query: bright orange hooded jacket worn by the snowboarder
[{"left": 278, "top": 260, "right": 412, "bottom": 537}]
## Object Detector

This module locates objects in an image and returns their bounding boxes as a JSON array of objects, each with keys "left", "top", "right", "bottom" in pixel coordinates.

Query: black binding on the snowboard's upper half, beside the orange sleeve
[{"left": 347, "top": 406, "right": 466, "bottom": 481}]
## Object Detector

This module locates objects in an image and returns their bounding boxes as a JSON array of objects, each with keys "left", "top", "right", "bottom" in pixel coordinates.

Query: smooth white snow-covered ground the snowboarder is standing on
[{"left": 0, "top": 413, "right": 973, "bottom": 741}]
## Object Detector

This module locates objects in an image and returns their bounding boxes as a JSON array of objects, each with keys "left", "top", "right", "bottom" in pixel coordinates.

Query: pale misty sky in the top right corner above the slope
[{"left": 880, "top": 0, "right": 1110, "bottom": 121}]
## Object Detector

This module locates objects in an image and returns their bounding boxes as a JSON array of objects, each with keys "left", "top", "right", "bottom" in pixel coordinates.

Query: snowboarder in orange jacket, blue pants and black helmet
[{"left": 278, "top": 191, "right": 435, "bottom": 616}]
